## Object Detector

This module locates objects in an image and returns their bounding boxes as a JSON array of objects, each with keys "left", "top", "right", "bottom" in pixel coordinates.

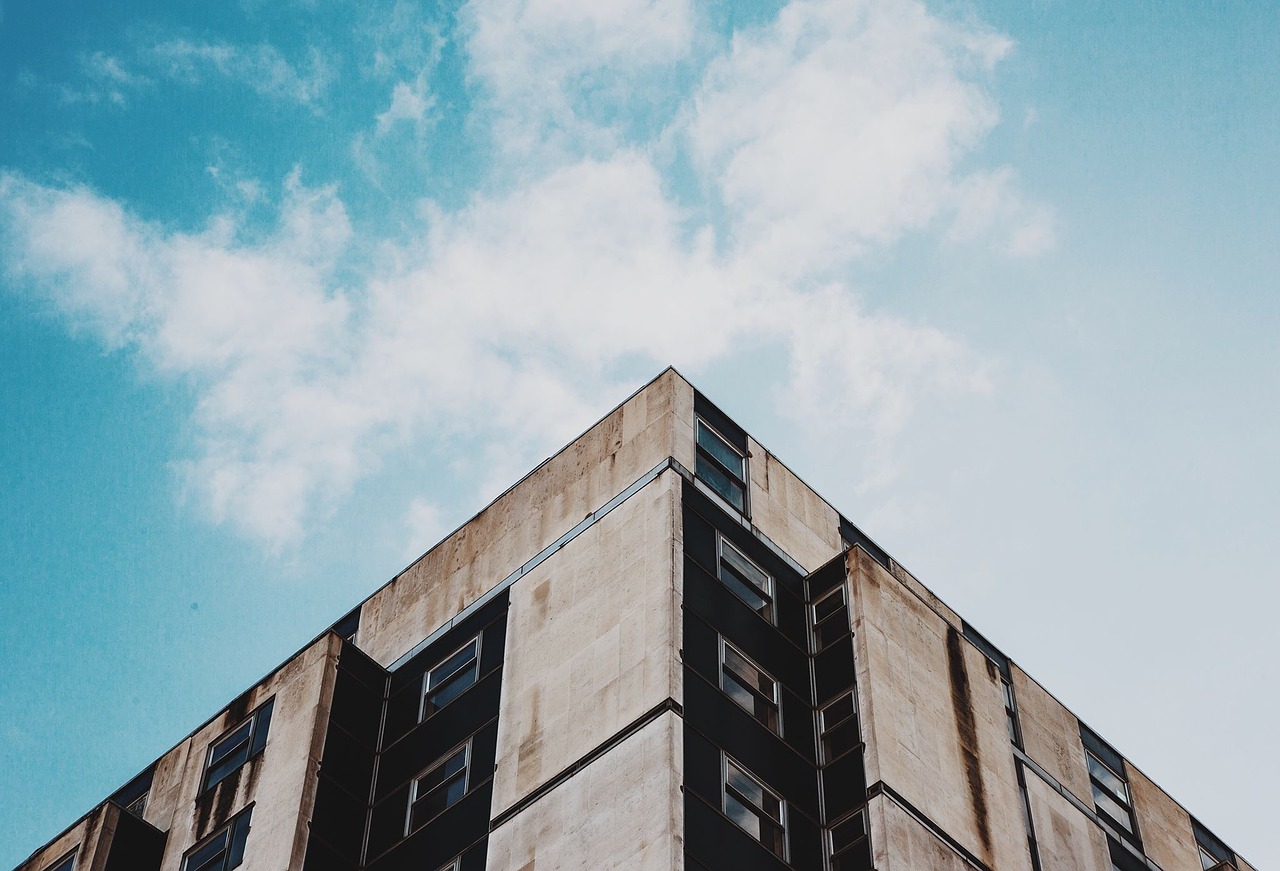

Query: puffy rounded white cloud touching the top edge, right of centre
[{"left": 689, "top": 0, "right": 1009, "bottom": 274}]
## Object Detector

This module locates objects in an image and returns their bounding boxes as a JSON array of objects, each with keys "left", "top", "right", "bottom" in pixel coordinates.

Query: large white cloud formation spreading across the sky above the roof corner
[{"left": 0, "top": 0, "right": 1043, "bottom": 547}]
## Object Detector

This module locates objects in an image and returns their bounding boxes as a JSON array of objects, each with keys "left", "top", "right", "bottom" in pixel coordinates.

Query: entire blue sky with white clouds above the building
[{"left": 0, "top": 0, "right": 1280, "bottom": 867}]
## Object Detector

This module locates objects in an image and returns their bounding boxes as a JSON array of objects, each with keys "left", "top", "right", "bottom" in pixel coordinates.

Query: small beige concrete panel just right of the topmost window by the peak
[{"left": 746, "top": 437, "right": 842, "bottom": 571}]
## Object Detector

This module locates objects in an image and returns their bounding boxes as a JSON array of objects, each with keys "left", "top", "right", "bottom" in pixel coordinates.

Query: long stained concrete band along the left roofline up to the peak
[{"left": 358, "top": 369, "right": 695, "bottom": 666}]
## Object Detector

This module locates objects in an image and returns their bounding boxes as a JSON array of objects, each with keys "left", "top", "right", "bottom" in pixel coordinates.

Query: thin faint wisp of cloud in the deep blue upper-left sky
[{"left": 150, "top": 38, "right": 335, "bottom": 106}]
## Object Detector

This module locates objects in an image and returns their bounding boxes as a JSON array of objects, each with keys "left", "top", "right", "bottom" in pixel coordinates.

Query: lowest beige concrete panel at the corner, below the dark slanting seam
[{"left": 488, "top": 712, "right": 685, "bottom": 871}]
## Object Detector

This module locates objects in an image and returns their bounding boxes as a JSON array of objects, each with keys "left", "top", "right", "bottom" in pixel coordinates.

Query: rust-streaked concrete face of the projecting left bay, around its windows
[{"left": 146, "top": 634, "right": 342, "bottom": 871}]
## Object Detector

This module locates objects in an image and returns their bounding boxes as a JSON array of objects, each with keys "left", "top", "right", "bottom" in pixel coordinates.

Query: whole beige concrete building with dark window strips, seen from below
[{"left": 19, "top": 369, "right": 1253, "bottom": 871}]
